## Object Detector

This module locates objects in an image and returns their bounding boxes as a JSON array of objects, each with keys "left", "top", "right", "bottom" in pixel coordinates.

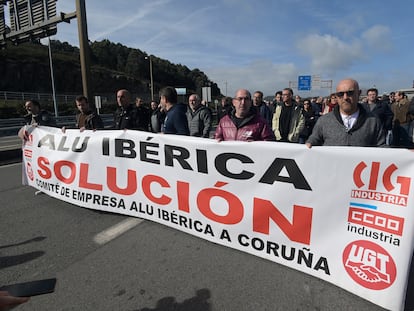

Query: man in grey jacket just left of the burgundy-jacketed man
[{"left": 186, "top": 94, "right": 212, "bottom": 138}]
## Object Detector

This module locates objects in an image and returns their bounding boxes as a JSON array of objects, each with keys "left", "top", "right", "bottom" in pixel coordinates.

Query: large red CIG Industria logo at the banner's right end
[{"left": 351, "top": 161, "right": 411, "bottom": 206}]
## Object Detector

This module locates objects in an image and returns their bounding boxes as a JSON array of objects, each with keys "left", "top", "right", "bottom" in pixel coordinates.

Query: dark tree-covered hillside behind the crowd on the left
[{"left": 0, "top": 40, "right": 221, "bottom": 115}]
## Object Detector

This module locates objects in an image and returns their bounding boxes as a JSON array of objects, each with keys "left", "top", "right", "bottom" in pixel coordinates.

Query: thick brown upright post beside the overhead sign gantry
[{"left": 76, "top": 0, "right": 92, "bottom": 100}]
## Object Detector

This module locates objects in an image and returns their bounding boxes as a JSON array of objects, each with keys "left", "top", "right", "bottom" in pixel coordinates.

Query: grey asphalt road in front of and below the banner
[{"left": 0, "top": 163, "right": 414, "bottom": 311}]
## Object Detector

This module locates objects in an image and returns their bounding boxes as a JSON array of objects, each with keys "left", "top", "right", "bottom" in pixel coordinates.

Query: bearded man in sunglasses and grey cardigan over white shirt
[{"left": 306, "top": 79, "right": 385, "bottom": 148}]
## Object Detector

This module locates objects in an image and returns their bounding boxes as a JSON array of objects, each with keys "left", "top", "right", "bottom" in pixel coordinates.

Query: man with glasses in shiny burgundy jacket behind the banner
[{"left": 214, "top": 89, "right": 275, "bottom": 141}]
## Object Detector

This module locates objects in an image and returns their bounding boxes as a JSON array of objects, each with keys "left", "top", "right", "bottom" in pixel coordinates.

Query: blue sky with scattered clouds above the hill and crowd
[{"left": 52, "top": 0, "right": 414, "bottom": 96}]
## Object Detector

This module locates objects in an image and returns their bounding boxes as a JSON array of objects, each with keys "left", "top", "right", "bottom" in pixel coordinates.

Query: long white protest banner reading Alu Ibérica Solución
[{"left": 23, "top": 127, "right": 414, "bottom": 310}]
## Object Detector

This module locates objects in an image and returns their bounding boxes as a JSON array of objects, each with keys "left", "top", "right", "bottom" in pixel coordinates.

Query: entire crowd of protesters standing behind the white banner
[{"left": 19, "top": 79, "right": 414, "bottom": 148}]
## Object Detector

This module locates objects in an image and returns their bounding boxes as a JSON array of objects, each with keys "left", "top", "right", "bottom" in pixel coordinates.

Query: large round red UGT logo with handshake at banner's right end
[{"left": 342, "top": 240, "right": 397, "bottom": 290}]
